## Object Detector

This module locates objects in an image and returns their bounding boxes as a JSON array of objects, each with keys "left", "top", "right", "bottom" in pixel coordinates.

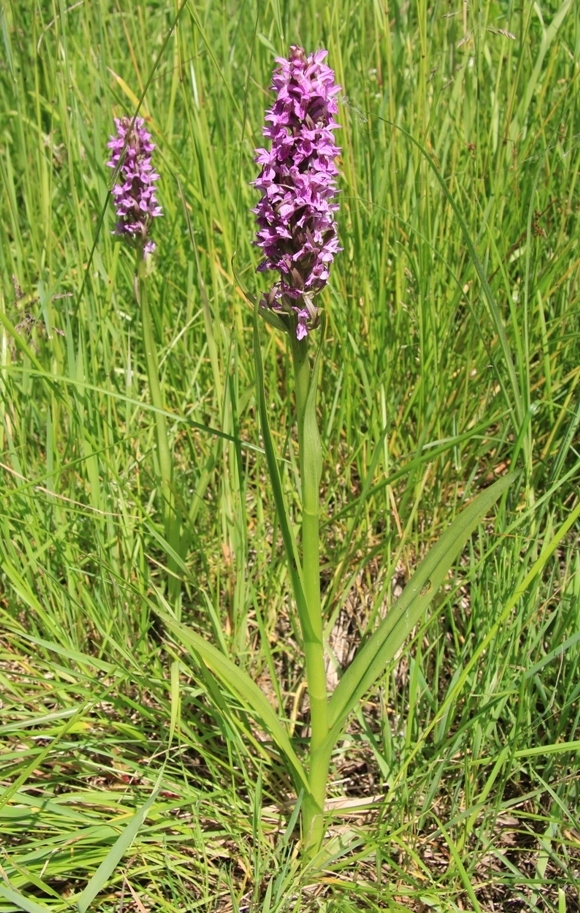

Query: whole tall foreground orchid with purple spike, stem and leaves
[{"left": 249, "top": 47, "right": 510, "bottom": 859}]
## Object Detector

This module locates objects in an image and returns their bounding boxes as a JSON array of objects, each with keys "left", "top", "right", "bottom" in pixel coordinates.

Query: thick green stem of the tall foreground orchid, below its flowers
[{"left": 292, "top": 339, "right": 331, "bottom": 857}]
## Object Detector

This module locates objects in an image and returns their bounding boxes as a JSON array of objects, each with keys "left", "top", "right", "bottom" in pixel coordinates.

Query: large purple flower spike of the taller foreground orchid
[{"left": 253, "top": 46, "right": 342, "bottom": 339}]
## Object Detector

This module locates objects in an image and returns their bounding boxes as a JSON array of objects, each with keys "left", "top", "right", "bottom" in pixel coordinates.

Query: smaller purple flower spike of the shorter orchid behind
[{"left": 107, "top": 117, "right": 163, "bottom": 258}]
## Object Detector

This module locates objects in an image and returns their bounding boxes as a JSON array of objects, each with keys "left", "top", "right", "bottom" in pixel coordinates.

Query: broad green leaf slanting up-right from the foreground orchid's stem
[{"left": 329, "top": 474, "right": 514, "bottom": 740}]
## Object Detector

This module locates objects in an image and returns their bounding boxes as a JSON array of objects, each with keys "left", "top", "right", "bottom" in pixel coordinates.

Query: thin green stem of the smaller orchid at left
[{"left": 135, "top": 250, "right": 181, "bottom": 620}]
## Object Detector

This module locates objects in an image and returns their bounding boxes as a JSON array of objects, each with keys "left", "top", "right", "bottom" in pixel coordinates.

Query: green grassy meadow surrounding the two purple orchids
[{"left": 0, "top": 0, "right": 580, "bottom": 913}]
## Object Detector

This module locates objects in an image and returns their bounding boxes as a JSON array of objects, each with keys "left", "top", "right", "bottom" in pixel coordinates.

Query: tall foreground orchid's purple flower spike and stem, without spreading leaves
[{"left": 254, "top": 46, "right": 341, "bottom": 854}]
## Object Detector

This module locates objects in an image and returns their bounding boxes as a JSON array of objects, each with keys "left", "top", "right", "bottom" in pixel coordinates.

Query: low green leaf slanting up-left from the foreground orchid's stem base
[{"left": 156, "top": 609, "right": 308, "bottom": 790}]
